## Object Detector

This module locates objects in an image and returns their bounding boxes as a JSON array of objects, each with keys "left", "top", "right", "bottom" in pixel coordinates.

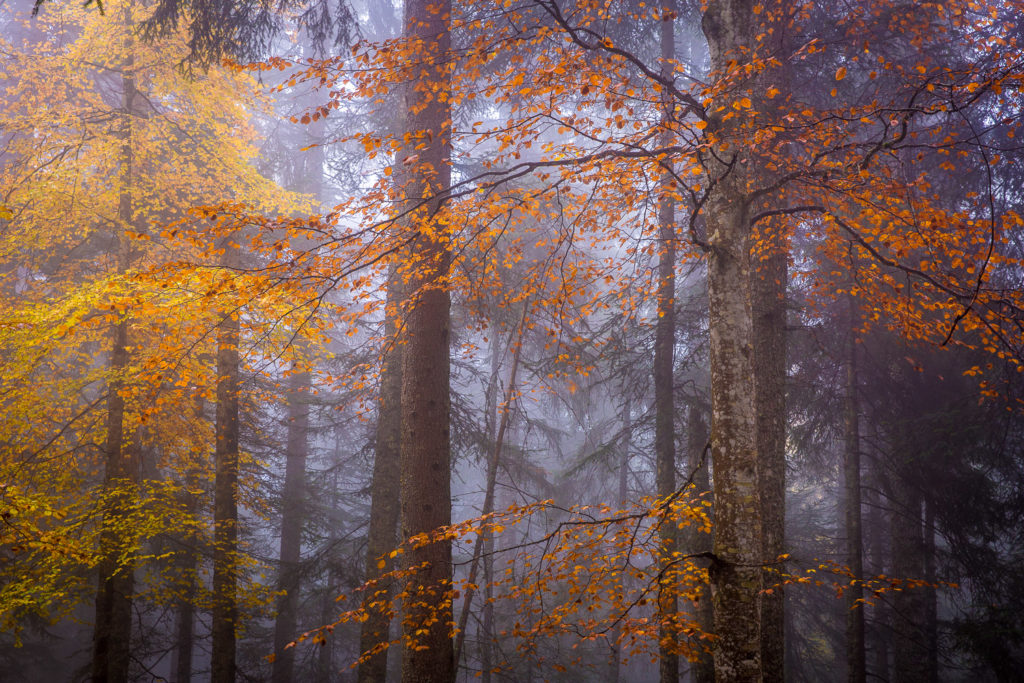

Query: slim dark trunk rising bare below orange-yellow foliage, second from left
[{"left": 210, "top": 301, "right": 240, "bottom": 683}]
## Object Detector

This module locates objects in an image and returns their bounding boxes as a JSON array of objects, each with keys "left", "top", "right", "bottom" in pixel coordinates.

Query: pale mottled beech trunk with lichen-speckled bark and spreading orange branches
[{"left": 702, "top": 0, "right": 765, "bottom": 683}]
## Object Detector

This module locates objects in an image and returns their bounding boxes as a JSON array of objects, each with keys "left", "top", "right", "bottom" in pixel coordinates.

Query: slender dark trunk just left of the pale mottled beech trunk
[{"left": 654, "top": 5, "right": 679, "bottom": 683}]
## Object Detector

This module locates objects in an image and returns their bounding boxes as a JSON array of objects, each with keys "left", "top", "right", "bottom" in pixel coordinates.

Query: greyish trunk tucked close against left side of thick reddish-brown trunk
[{"left": 357, "top": 269, "right": 404, "bottom": 683}]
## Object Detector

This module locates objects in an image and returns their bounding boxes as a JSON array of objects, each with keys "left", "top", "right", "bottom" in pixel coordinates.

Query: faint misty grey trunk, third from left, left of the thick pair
[{"left": 271, "top": 362, "right": 311, "bottom": 683}]
